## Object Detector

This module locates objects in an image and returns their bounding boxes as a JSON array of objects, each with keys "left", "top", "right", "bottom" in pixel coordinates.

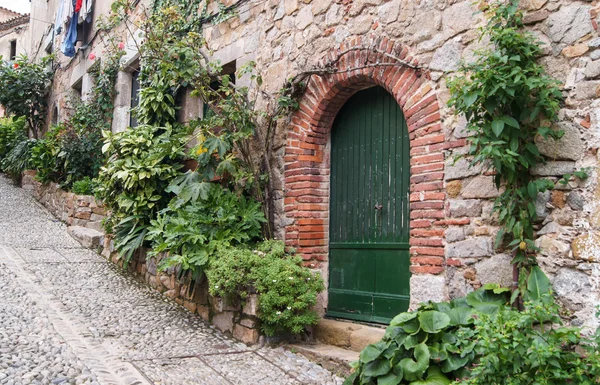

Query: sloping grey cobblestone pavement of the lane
[{"left": 0, "top": 176, "right": 342, "bottom": 385}]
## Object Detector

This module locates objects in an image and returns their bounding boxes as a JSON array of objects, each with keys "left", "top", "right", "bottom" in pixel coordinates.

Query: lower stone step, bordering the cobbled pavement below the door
[{"left": 287, "top": 343, "right": 359, "bottom": 378}]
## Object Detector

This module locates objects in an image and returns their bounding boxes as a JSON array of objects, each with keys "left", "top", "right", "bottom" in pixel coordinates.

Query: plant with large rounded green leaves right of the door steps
[{"left": 344, "top": 285, "right": 510, "bottom": 385}]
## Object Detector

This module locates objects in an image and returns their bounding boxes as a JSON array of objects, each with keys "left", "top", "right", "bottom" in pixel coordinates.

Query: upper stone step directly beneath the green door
[{"left": 314, "top": 318, "right": 385, "bottom": 352}]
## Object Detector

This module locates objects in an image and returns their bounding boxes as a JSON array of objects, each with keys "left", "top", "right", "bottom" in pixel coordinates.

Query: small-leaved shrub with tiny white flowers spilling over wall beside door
[{"left": 206, "top": 241, "right": 324, "bottom": 335}]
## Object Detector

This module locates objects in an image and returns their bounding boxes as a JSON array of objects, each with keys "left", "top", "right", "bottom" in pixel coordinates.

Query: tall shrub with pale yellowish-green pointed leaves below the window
[{"left": 96, "top": 126, "right": 188, "bottom": 260}]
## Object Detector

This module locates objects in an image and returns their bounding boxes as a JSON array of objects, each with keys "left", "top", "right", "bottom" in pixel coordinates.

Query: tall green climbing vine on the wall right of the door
[{"left": 449, "top": 0, "right": 563, "bottom": 266}]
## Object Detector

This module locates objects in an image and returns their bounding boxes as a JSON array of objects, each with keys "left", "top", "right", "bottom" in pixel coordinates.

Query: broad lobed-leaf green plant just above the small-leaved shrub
[{"left": 147, "top": 184, "right": 265, "bottom": 278}]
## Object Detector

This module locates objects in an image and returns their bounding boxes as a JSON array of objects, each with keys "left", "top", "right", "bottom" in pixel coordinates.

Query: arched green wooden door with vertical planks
[{"left": 327, "top": 87, "right": 410, "bottom": 323}]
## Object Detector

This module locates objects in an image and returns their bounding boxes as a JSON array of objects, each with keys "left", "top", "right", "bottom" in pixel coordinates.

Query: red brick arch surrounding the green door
[{"left": 284, "top": 38, "right": 447, "bottom": 274}]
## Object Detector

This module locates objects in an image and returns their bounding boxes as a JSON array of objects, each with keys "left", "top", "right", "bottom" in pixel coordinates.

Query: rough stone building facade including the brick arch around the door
[{"left": 25, "top": 0, "right": 600, "bottom": 326}]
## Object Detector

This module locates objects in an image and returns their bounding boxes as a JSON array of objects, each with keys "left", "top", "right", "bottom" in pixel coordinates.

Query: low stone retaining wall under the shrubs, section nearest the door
[{"left": 102, "top": 237, "right": 260, "bottom": 344}]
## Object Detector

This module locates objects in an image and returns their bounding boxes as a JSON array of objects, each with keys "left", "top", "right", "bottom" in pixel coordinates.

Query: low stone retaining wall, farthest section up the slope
[{"left": 21, "top": 171, "right": 106, "bottom": 231}]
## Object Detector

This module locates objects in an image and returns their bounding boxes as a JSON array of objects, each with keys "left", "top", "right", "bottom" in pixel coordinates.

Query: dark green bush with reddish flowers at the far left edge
[{"left": 0, "top": 56, "right": 53, "bottom": 138}]
